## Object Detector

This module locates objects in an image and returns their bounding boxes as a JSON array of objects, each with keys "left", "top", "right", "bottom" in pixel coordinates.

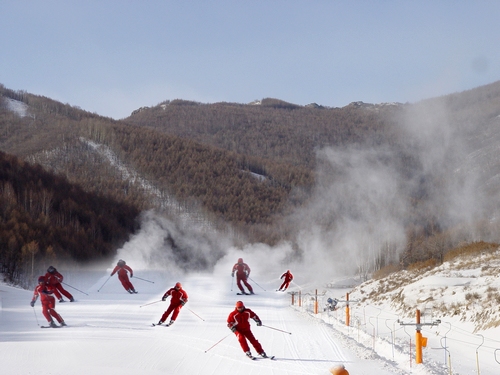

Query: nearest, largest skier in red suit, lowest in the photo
[{"left": 227, "top": 301, "right": 267, "bottom": 359}]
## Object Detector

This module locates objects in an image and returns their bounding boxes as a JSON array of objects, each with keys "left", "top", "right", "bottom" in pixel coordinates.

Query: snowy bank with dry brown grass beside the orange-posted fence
[{"left": 325, "top": 249, "right": 500, "bottom": 375}]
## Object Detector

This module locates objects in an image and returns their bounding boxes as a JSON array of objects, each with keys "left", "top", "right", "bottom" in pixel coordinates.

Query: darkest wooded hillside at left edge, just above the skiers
[{"left": 0, "top": 152, "right": 139, "bottom": 285}]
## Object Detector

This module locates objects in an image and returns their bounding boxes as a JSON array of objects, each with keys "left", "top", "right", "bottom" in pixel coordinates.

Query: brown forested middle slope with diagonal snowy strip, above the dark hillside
[{"left": 0, "top": 89, "right": 313, "bottom": 235}]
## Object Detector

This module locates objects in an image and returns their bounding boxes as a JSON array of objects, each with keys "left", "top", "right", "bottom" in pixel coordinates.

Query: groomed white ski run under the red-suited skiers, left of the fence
[{"left": 0, "top": 270, "right": 392, "bottom": 375}]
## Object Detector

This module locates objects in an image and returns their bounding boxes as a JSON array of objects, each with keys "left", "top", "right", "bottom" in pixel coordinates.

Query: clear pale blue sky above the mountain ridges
[{"left": 0, "top": 0, "right": 500, "bottom": 119}]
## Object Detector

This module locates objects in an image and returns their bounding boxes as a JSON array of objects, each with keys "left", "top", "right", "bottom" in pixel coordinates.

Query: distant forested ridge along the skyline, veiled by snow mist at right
[{"left": 125, "top": 82, "right": 500, "bottom": 260}]
